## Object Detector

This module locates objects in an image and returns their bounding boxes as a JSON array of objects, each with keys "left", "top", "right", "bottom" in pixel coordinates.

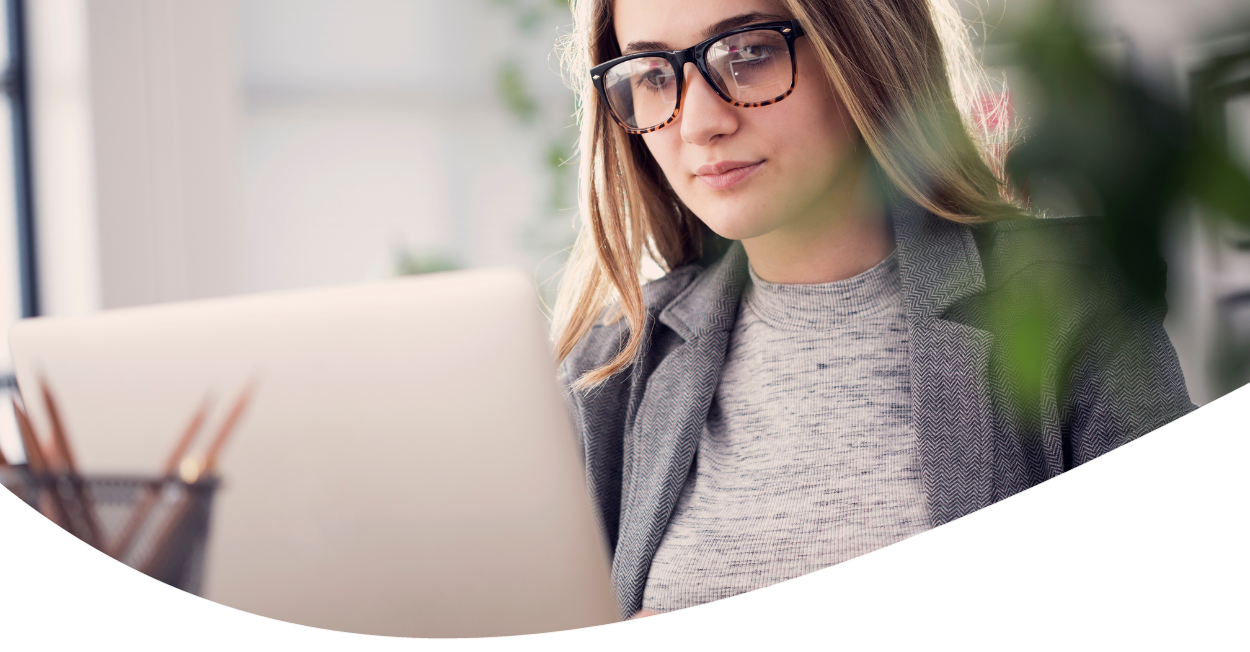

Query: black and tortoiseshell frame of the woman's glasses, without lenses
[{"left": 590, "top": 20, "right": 804, "bottom": 134}]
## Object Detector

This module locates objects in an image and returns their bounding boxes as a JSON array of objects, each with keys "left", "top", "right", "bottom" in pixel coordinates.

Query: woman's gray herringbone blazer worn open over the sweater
[{"left": 560, "top": 205, "right": 1194, "bottom": 616}]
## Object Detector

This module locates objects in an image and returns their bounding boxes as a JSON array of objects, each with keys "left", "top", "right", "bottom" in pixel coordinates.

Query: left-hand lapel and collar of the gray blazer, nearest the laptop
[{"left": 613, "top": 245, "right": 748, "bottom": 613}]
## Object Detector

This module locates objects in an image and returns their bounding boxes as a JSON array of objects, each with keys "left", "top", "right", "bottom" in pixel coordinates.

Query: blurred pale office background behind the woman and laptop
[{"left": 0, "top": 0, "right": 1250, "bottom": 507}]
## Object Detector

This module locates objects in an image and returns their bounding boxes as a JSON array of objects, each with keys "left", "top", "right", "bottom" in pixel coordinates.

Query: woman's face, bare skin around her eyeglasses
[{"left": 614, "top": 0, "right": 859, "bottom": 240}]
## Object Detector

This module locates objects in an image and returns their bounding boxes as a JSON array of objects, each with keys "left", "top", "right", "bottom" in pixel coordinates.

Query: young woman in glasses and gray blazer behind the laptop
[{"left": 555, "top": 0, "right": 1193, "bottom": 615}]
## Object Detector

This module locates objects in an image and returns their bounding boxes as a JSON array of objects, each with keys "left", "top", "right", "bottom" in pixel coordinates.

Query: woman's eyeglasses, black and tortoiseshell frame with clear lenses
[{"left": 590, "top": 20, "right": 804, "bottom": 134}]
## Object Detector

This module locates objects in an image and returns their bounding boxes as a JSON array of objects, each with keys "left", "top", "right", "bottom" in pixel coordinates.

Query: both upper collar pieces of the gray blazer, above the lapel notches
[{"left": 659, "top": 201, "right": 985, "bottom": 341}]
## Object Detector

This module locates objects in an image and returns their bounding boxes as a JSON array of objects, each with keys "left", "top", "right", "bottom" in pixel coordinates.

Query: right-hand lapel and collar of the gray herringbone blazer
[{"left": 895, "top": 205, "right": 995, "bottom": 526}]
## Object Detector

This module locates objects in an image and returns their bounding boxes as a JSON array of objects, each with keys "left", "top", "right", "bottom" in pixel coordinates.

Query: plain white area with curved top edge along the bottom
[{"left": 0, "top": 386, "right": 1250, "bottom": 651}]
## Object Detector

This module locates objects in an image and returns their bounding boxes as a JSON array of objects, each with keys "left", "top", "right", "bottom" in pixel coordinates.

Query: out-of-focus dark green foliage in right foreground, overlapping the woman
[{"left": 999, "top": 0, "right": 1250, "bottom": 396}]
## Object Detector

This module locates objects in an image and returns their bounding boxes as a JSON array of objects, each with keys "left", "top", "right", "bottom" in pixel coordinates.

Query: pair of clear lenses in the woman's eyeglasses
[{"left": 604, "top": 30, "right": 794, "bottom": 129}]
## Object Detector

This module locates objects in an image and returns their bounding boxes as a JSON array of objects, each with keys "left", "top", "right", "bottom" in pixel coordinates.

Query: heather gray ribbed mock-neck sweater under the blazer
[{"left": 643, "top": 254, "right": 929, "bottom": 611}]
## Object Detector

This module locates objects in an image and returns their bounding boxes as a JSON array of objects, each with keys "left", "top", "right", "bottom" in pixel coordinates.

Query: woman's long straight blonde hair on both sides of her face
[{"left": 553, "top": 0, "right": 1021, "bottom": 388}]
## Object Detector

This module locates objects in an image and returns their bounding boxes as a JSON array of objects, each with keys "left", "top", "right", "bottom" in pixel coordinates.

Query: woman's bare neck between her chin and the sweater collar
[{"left": 743, "top": 154, "right": 894, "bottom": 284}]
